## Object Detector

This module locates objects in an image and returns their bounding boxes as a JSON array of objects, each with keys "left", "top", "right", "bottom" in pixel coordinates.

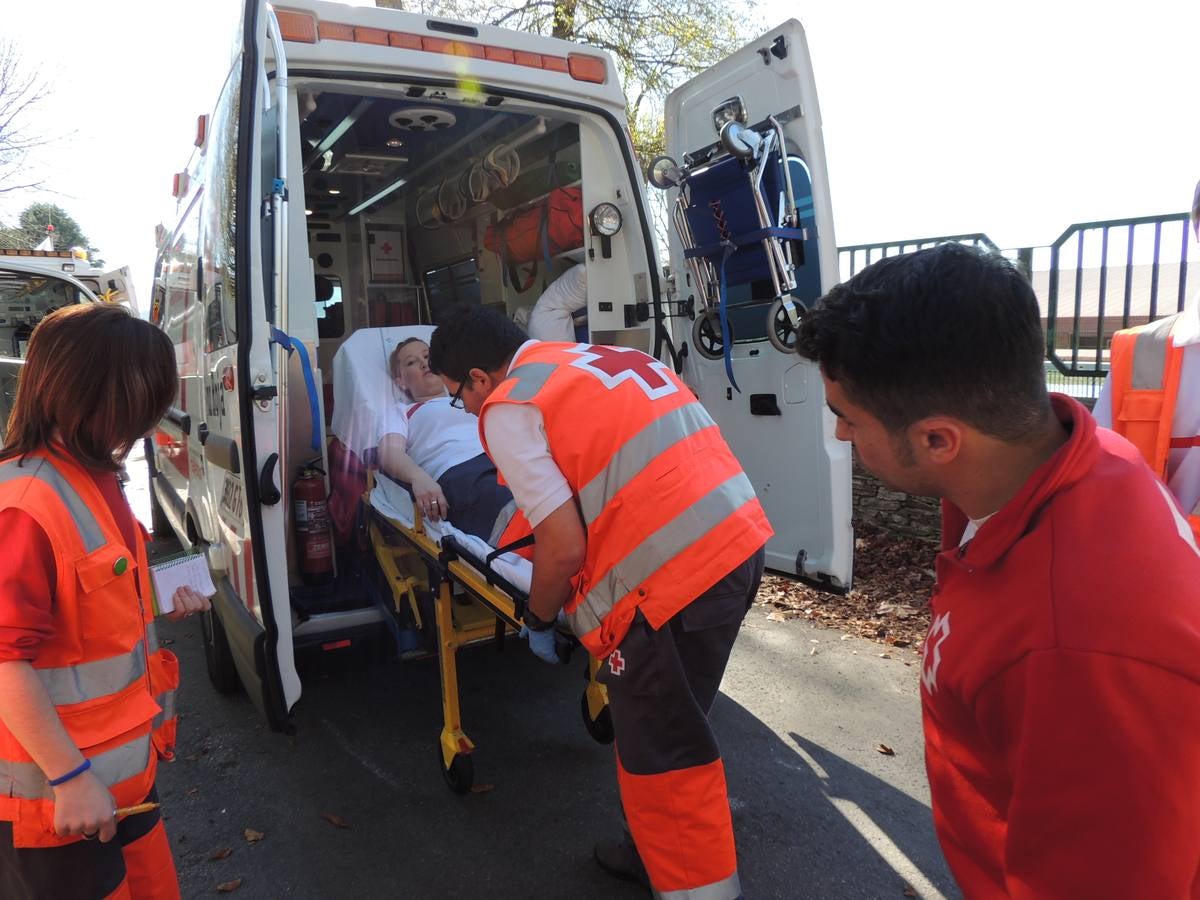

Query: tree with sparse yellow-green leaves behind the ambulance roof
[{"left": 393, "top": 0, "right": 752, "bottom": 169}]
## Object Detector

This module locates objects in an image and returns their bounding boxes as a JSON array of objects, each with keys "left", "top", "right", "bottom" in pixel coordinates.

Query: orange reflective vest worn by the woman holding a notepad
[{"left": 0, "top": 452, "right": 179, "bottom": 847}]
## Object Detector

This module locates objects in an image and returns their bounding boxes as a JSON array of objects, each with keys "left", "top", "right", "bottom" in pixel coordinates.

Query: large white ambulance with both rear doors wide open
[{"left": 148, "top": 0, "right": 853, "bottom": 728}]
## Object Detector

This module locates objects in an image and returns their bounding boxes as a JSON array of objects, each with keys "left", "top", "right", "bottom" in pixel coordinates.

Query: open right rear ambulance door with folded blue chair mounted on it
[{"left": 666, "top": 19, "right": 854, "bottom": 589}]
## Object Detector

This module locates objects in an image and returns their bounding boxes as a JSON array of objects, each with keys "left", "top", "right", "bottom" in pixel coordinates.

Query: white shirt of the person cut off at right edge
[{"left": 1092, "top": 301, "right": 1200, "bottom": 515}]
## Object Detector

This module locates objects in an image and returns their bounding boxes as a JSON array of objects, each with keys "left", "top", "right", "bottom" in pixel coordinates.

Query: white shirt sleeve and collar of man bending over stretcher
[{"left": 484, "top": 340, "right": 573, "bottom": 528}]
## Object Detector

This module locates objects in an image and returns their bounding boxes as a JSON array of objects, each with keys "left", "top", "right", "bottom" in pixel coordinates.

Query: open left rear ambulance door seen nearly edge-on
[{"left": 223, "top": 0, "right": 304, "bottom": 730}]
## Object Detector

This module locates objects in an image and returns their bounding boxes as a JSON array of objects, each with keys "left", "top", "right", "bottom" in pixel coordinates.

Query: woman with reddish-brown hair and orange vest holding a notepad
[{"left": 0, "top": 304, "right": 209, "bottom": 898}]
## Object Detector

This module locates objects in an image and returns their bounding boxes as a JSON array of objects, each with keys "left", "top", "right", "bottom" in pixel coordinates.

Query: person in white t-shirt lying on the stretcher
[{"left": 379, "top": 337, "right": 516, "bottom": 546}]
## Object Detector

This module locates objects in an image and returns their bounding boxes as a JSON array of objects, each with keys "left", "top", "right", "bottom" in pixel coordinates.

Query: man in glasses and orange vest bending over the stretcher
[{"left": 431, "top": 307, "right": 772, "bottom": 900}]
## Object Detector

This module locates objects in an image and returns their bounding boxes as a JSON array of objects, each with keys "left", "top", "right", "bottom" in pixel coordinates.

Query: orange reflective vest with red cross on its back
[{"left": 479, "top": 342, "right": 773, "bottom": 659}]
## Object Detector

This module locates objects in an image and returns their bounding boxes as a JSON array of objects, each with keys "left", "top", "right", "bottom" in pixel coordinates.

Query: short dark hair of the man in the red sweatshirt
[{"left": 797, "top": 244, "right": 1050, "bottom": 443}]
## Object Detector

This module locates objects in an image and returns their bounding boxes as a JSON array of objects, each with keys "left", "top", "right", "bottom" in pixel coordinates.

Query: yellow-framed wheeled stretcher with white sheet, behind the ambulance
[{"left": 334, "top": 325, "right": 612, "bottom": 793}]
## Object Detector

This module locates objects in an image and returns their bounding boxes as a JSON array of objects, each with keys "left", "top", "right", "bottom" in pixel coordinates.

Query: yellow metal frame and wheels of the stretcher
[{"left": 362, "top": 480, "right": 613, "bottom": 793}]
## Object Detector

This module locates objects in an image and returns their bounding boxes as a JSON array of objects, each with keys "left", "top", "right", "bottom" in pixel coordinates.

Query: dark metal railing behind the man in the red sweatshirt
[{"left": 838, "top": 212, "right": 1200, "bottom": 381}]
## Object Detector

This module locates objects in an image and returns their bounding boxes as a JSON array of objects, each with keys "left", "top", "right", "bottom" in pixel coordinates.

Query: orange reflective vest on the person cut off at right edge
[{"left": 1109, "top": 313, "right": 1200, "bottom": 539}]
